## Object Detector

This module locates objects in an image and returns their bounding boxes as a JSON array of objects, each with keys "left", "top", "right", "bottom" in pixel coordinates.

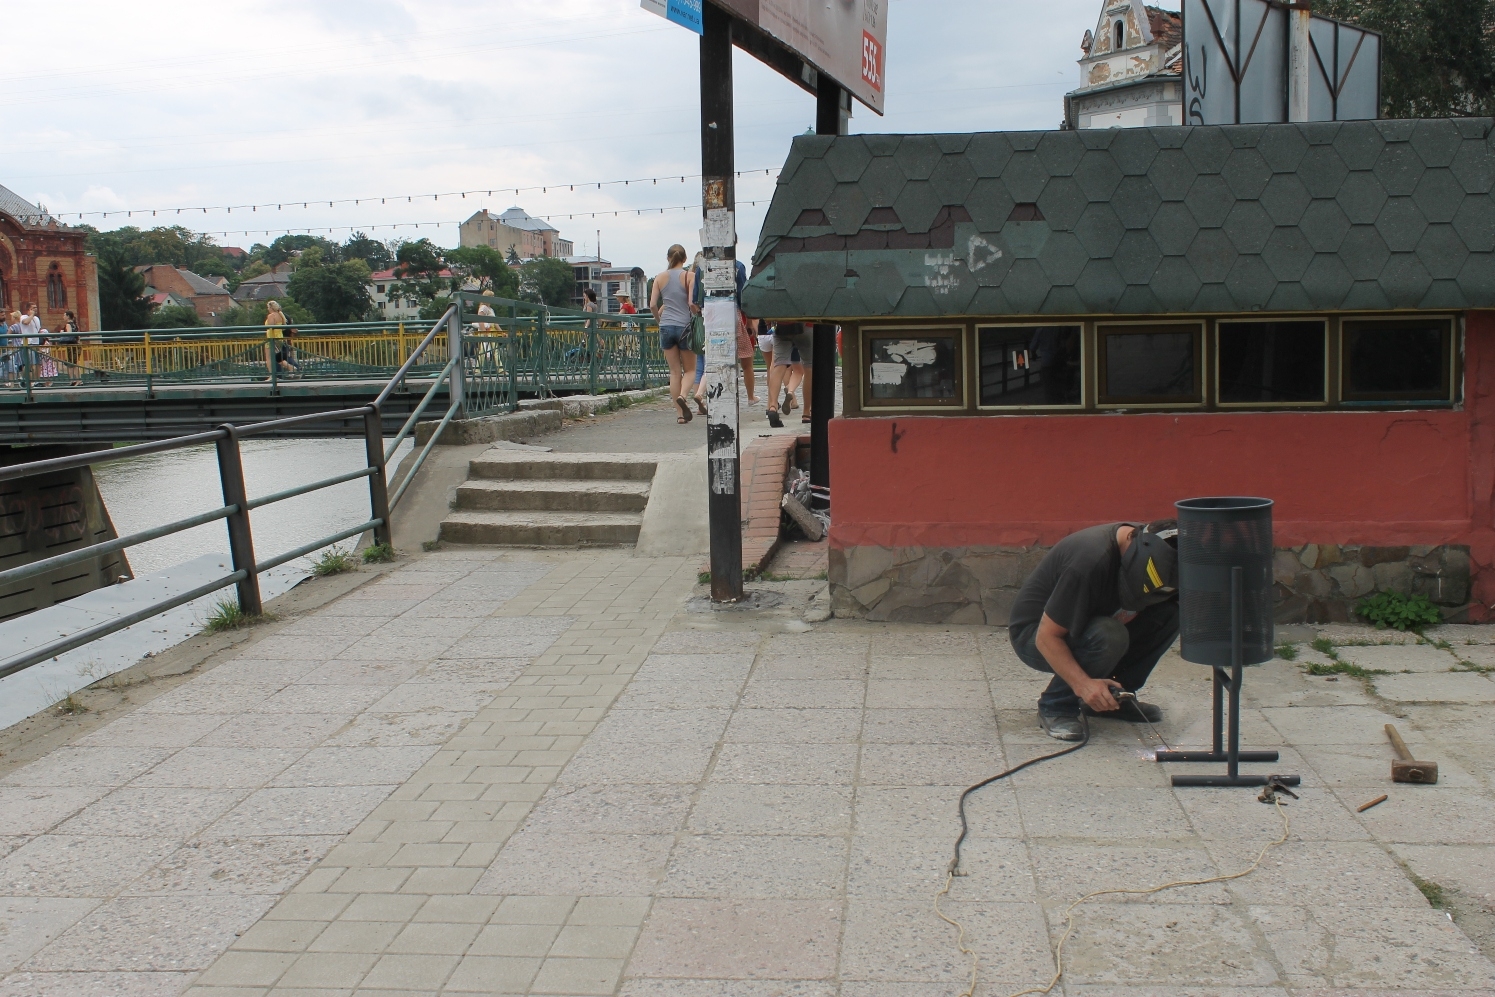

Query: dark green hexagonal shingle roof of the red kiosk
[{"left": 743, "top": 118, "right": 1495, "bottom": 318}]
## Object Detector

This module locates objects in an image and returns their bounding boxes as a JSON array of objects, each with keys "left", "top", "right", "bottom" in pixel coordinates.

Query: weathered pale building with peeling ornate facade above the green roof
[{"left": 1064, "top": 0, "right": 1184, "bottom": 129}]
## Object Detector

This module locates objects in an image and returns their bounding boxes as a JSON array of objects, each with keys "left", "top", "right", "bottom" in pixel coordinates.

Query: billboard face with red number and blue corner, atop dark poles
[{"left": 640, "top": 0, "right": 890, "bottom": 114}]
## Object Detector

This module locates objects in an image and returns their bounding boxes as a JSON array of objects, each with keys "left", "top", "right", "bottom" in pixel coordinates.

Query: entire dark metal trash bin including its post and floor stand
[{"left": 1156, "top": 498, "right": 1298, "bottom": 786}]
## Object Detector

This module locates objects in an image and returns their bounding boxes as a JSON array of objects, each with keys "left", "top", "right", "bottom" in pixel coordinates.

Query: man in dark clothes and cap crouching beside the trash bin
[{"left": 1008, "top": 519, "right": 1178, "bottom": 741}]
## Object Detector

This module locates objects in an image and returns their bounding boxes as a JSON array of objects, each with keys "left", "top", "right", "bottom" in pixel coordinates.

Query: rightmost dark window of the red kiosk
[{"left": 1343, "top": 318, "right": 1453, "bottom": 402}]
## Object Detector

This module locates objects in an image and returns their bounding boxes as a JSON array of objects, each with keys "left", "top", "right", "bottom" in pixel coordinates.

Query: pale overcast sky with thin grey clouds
[{"left": 0, "top": 0, "right": 1148, "bottom": 271}]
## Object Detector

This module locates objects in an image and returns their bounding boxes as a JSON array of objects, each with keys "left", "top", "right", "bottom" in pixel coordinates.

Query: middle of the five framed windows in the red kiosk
[{"left": 1097, "top": 326, "right": 1203, "bottom": 405}]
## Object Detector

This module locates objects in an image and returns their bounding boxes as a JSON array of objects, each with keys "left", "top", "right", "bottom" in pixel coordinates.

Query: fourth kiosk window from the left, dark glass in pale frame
[{"left": 1217, "top": 321, "right": 1329, "bottom": 405}]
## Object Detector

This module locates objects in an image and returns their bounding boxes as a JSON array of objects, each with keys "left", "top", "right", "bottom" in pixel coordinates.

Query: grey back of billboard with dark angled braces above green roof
[{"left": 1183, "top": 0, "right": 1381, "bottom": 124}]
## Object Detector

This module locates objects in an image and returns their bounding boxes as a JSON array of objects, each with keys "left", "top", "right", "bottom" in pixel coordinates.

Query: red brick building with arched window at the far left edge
[{"left": 0, "top": 187, "right": 99, "bottom": 330}]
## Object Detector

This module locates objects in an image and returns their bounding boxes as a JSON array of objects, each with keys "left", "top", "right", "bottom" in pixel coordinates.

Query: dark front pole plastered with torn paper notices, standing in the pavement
[{"left": 701, "top": 3, "right": 743, "bottom": 602}]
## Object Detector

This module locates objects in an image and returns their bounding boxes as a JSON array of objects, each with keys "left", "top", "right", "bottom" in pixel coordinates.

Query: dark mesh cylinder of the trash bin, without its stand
[{"left": 1174, "top": 498, "right": 1274, "bottom": 668}]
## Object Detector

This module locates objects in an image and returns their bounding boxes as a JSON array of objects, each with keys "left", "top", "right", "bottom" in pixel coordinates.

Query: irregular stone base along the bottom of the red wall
[{"left": 828, "top": 544, "right": 1470, "bottom": 626}]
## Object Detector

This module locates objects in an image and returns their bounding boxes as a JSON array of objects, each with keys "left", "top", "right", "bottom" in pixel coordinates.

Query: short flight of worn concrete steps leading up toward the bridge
[{"left": 441, "top": 448, "right": 658, "bottom": 547}]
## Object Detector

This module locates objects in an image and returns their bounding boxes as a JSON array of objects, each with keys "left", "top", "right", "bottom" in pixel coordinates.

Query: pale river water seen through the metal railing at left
[{"left": 0, "top": 439, "right": 410, "bottom": 728}]
